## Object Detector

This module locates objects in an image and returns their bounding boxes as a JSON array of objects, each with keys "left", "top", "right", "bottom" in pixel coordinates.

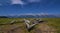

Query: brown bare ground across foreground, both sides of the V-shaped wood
[{"left": 0, "top": 23, "right": 55, "bottom": 33}]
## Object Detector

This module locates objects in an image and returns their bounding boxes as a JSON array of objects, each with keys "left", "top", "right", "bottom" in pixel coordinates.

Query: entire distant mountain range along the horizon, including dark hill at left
[{"left": 0, "top": 15, "right": 60, "bottom": 18}]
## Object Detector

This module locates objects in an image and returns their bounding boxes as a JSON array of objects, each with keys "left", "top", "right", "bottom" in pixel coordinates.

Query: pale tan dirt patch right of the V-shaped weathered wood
[{"left": 35, "top": 23, "right": 56, "bottom": 33}]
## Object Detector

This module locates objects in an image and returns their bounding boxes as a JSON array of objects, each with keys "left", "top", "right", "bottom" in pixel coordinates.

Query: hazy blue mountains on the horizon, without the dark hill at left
[{"left": 10, "top": 15, "right": 59, "bottom": 18}]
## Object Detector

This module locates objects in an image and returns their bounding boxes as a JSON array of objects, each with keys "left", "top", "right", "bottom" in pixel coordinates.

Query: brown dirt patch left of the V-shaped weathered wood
[{"left": 0, "top": 23, "right": 25, "bottom": 33}]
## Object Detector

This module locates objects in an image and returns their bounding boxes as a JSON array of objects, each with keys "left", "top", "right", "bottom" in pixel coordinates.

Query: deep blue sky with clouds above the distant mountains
[{"left": 0, "top": 0, "right": 60, "bottom": 15}]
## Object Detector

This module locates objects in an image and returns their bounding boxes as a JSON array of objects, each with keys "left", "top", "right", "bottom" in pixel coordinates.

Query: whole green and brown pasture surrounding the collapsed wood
[{"left": 0, "top": 18, "right": 60, "bottom": 33}]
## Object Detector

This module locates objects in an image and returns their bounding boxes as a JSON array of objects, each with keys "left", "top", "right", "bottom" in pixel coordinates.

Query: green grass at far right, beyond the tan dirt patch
[{"left": 43, "top": 18, "right": 60, "bottom": 33}]
